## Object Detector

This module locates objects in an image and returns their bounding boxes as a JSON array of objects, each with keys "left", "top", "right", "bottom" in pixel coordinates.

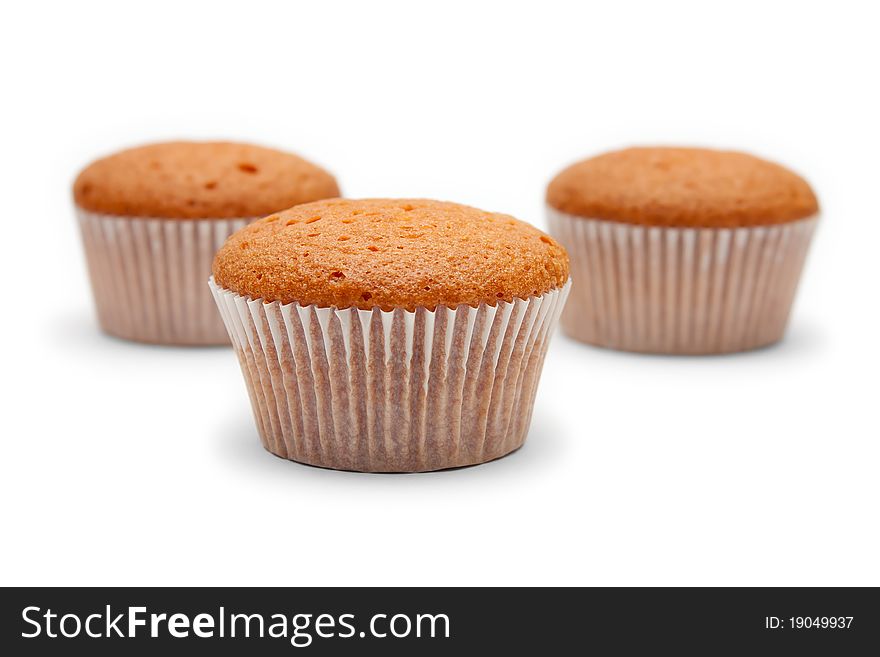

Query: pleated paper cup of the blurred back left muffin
[{"left": 77, "top": 208, "right": 253, "bottom": 345}]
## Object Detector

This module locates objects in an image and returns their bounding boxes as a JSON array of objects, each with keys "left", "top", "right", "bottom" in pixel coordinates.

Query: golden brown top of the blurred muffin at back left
[{"left": 73, "top": 141, "right": 339, "bottom": 219}]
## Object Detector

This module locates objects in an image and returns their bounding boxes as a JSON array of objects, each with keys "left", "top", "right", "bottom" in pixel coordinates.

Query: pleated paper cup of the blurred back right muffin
[{"left": 547, "top": 207, "right": 818, "bottom": 354}]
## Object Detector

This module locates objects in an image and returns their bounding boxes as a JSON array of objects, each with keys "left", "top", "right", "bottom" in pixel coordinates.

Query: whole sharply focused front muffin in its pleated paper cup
[{"left": 210, "top": 199, "right": 569, "bottom": 472}]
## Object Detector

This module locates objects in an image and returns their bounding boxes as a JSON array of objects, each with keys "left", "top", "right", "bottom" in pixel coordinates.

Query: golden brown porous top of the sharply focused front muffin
[{"left": 214, "top": 199, "right": 568, "bottom": 310}]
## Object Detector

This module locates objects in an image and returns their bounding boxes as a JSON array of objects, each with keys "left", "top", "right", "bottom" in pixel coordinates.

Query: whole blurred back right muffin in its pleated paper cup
[{"left": 547, "top": 148, "right": 819, "bottom": 354}]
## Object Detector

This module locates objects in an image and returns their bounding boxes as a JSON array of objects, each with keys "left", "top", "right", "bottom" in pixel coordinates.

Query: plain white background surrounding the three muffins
[{"left": 0, "top": 0, "right": 880, "bottom": 585}]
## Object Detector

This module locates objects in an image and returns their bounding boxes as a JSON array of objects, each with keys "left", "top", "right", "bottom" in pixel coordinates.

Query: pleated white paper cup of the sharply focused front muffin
[{"left": 209, "top": 278, "right": 571, "bottom": 472}]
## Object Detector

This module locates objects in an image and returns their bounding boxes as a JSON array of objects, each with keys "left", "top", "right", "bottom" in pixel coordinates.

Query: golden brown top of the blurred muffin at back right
[{"left": 547, "top": 147, "right": 819, "bottom": 228}]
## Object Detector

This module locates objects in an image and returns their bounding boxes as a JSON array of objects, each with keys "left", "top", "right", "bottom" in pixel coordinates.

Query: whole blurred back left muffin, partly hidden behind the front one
[{"left": 73, "top": 142, "right": 339, "bottom": 345}]
